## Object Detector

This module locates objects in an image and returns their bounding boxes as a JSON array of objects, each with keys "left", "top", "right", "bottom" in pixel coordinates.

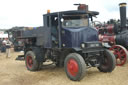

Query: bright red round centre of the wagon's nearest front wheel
[{"left": 67, "top": 59, "right": 79, "bottom": 76}]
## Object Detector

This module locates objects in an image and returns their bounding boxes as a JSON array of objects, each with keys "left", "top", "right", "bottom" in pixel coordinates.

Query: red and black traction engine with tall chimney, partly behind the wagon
[{"left": 96, "top": 3, "right": 128, "bottom": 66}]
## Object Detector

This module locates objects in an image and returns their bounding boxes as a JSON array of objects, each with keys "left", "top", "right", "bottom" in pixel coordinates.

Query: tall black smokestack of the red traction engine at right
[{"left": 119, "top": 3, "right": 127, "bottom": 27}]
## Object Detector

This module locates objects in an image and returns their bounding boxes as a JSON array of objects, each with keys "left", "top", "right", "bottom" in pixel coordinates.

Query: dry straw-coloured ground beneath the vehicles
[{"left": 0, "top": 48, "right": 128, "bottom": 85}]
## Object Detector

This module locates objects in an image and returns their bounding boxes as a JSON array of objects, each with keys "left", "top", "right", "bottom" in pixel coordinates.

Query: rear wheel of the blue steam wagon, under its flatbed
[{"left": 25, "top": 51, "right": 42, "bottom": 71}]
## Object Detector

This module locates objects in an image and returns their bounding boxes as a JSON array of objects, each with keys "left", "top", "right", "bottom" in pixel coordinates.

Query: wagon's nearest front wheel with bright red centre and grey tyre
[{"left": 64, "top": 53, "right": 86, "bottom": 81}]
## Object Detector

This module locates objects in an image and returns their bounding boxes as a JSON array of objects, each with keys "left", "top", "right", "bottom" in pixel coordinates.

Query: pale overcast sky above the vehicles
[{"left": 0, "top": 0, "right": 128, "bottom": 29}]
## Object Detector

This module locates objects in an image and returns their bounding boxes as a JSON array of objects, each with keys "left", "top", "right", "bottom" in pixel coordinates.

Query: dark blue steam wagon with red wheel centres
[{"left": 21, "top": 4, "right": 116, "bottom": 81}]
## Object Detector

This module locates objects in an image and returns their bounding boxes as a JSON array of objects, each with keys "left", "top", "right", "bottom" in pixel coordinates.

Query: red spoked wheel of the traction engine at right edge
[{"left": 110, "top": 45, "right": 128, "bottom": 66}]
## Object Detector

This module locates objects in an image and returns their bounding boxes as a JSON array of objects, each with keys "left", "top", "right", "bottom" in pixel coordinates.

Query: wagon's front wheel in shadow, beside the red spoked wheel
[{"left": 98, "top": 50, "right": 116, "bottom": 72}]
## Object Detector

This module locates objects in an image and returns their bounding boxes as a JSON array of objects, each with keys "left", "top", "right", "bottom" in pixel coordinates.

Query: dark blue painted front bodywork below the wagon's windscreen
[{"left": 61, "top": 27, "right": 98, "bottom": 48}]
